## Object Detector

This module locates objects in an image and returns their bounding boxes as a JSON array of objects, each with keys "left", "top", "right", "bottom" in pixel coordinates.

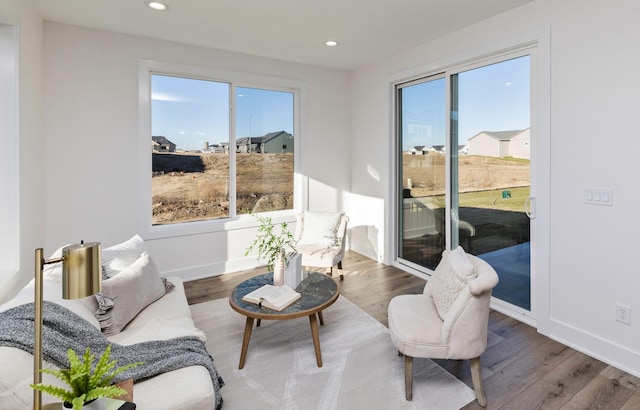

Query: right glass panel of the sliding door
[{"left": 451, "top": 55, "right": 531, "bottom": 310}]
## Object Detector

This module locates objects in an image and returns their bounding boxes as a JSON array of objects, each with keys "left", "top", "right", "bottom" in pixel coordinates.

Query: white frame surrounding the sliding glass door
[{"left": 385, "top": 26, "right": 551, "bottom": 326}]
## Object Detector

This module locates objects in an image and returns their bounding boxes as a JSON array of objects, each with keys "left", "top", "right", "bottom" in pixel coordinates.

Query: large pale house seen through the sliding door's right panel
[{"left": 467, "top": 128, "right": 531, "bottom": 159}]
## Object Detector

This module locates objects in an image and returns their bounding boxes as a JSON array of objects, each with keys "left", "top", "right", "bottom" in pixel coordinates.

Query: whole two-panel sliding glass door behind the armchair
[{"left": 396, "top": 52, "right": 532, "bottom": 311}]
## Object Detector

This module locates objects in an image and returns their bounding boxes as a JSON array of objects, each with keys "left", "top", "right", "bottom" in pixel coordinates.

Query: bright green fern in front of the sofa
[{"left": 31, "top": 345, "right": 142, "bottom": 410}]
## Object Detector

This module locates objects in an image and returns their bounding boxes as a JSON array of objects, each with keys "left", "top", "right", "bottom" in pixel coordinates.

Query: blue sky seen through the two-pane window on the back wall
[{"left": 151, "top": 75, "right": 294, "bottom": 150}]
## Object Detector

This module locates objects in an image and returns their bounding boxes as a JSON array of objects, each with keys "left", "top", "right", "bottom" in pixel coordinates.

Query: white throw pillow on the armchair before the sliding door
[{"left": 430, "top": 246, "right": 477, "bottom": 320}]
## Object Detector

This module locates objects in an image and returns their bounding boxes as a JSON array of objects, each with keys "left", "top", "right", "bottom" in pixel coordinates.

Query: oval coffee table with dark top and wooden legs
[{"left": 229, "top": 272, "right": 340, "bottom": 369}]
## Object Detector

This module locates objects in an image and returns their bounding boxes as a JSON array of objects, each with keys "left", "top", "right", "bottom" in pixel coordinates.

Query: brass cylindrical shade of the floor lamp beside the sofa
[{"left": 62, "top": 242, "right": 102, "bottom": 299}]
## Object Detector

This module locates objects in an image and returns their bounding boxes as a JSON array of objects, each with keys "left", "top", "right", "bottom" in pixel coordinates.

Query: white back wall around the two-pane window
[{"left": 44, "top": 22, "right": 349, "bottom": 279}]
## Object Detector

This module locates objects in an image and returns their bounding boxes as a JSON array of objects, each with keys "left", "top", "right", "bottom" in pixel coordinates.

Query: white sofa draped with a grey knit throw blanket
[{"left": 0, "top": 237, "right": 224, "bottom": 410}]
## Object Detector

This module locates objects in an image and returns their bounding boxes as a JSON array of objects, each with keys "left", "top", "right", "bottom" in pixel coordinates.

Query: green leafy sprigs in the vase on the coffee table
[{"left": 245, "top": 215, "right": 296, "bottom": 270}]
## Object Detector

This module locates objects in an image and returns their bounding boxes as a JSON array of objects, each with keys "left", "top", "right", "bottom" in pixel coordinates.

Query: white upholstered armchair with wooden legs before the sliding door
[{"left": 388, "top": 247, "right": 498, "bottom": 407}]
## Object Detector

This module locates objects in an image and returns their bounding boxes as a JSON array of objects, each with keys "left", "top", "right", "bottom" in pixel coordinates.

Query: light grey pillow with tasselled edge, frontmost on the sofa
[{"left": 96, "top": 253, "right": 166, "bottom": 335}]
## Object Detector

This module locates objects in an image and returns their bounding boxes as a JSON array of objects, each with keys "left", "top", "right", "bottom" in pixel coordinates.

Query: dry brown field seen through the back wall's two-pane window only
[{"left": 152, "top": 153, "right": 293, "bottom": 224}]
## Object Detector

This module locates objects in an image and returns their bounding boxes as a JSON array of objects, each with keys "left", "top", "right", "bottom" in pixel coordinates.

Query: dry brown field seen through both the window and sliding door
[{"left": 152, "top": 153, "right": 529, "bottom": 224}]
